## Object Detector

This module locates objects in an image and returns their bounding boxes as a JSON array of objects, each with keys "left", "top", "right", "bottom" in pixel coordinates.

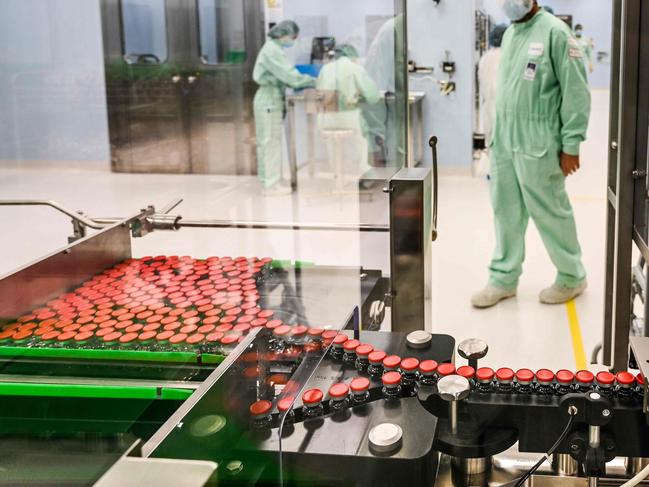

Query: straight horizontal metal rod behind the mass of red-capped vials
[{"left": 178, "top": 220, "right": 390, "bottom": 233}]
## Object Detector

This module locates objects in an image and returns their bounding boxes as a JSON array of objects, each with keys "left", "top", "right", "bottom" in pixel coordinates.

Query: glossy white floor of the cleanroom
[{"left": 0, "top": 92, "right": 608, "bottom": 369}]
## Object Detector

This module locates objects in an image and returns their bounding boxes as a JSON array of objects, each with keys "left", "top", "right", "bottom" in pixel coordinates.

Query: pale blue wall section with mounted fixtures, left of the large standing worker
[{"left": 408, "top": 0, "right": 475, "bottom": 169}]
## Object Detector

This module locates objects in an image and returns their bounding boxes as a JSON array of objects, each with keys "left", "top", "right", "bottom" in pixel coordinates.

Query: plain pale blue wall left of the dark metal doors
[{"left": 0, "top": 0, "right": 110, "bottom": 165}]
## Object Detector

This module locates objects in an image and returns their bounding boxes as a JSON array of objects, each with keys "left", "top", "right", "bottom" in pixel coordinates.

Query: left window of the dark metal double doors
[{"left": 122, "top": 0, "right": 167, "bottom": 64}]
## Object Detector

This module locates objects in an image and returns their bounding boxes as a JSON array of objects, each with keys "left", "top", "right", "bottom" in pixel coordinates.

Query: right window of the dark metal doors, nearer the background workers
[{"left": 197, "top": 0, "right": 246, "bottom": 64}]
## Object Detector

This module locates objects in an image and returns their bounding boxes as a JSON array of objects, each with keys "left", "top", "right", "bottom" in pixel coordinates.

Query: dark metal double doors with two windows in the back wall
[{"left": 102, "top": 0, "right": 264, "bottom": 174}]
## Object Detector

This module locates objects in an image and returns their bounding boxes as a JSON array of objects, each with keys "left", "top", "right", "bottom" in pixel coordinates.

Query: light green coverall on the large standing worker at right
[{"left": 489, "top": 11, "right": 591, "bottom": 290}]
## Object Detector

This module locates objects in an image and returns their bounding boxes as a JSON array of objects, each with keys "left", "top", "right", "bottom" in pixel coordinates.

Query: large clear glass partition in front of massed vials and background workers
[{"left": 0, "top": 0, "right": 407, "bottom": 485}]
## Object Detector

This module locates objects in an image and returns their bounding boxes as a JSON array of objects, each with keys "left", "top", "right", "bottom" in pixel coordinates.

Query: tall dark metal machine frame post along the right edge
[{"left": 604, "top": 0, "right": 649, "bottom": 369}]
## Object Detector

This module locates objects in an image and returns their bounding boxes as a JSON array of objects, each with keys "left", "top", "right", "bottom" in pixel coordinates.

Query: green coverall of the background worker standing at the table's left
[{"left": 252, "top": 39, "right": 315, "bottom": 188}]
